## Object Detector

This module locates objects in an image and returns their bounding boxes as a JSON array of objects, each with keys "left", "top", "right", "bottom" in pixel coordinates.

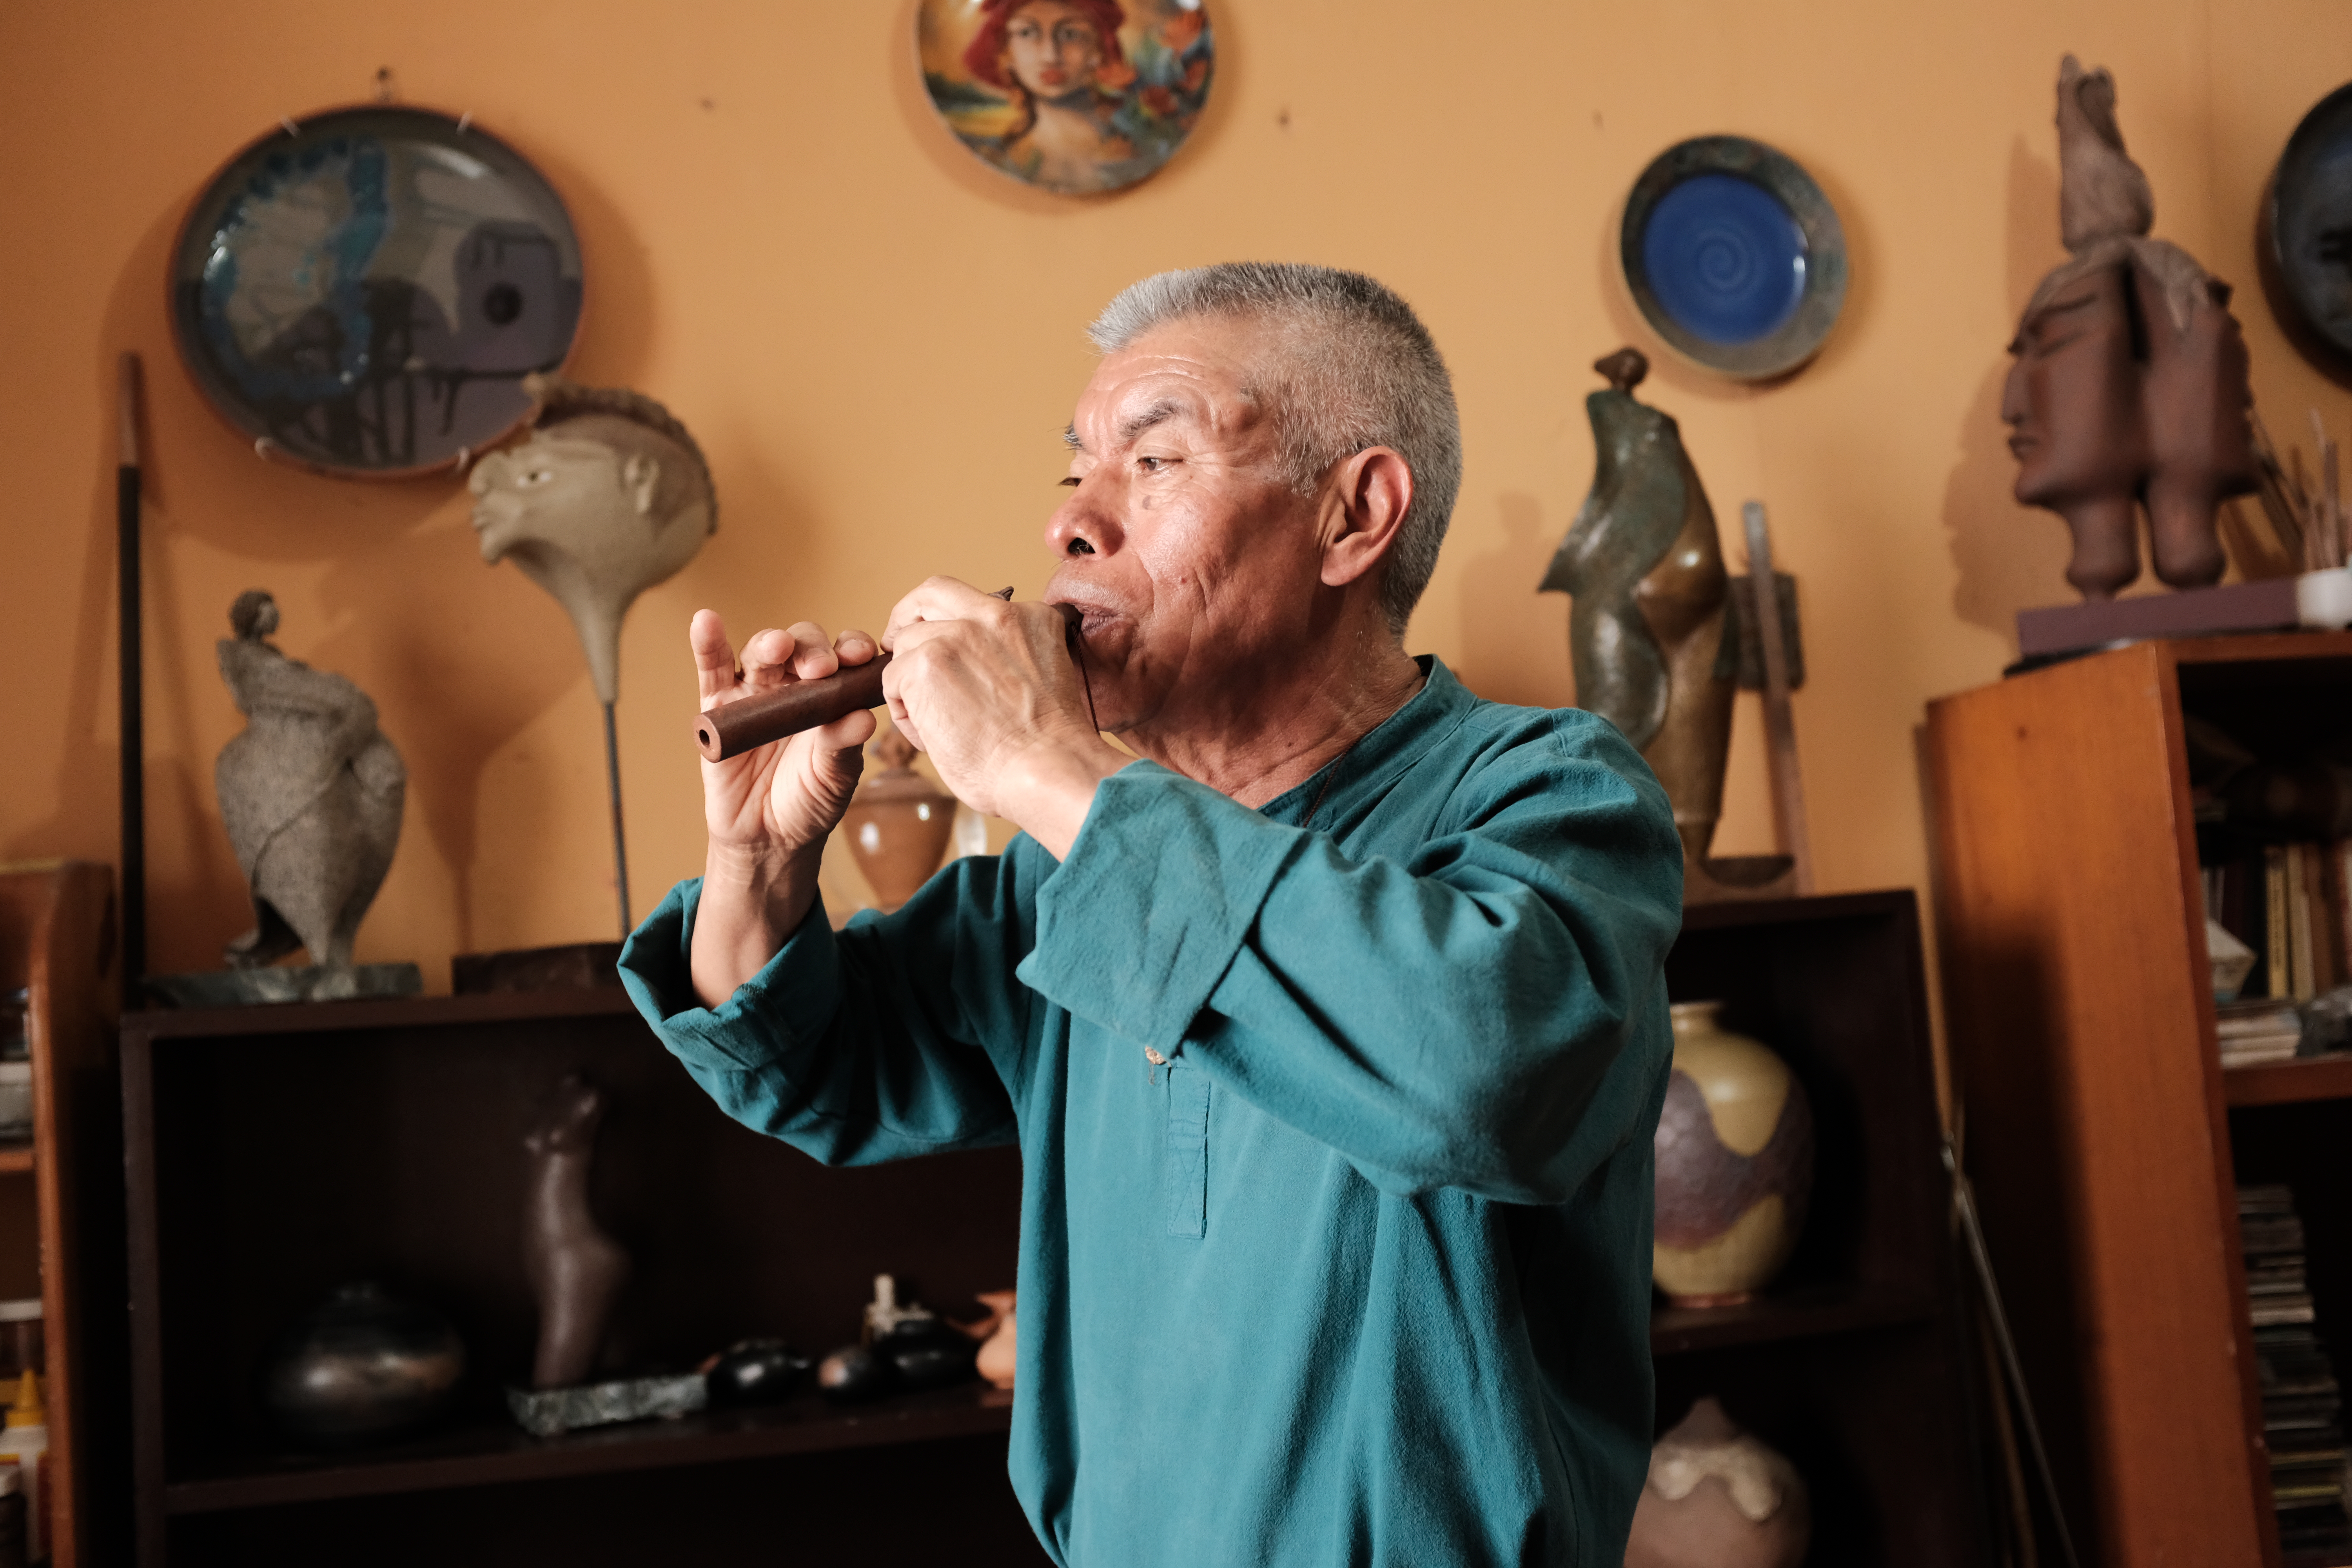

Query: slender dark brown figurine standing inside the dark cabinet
[{"left": 522, "top": 1074, "right": 628, "bottom": 1389}]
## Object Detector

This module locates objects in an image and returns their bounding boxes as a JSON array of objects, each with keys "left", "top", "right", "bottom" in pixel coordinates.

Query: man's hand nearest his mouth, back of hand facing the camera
[{"left": 882, "top": 578, "right": 1134, "bottom": 858}]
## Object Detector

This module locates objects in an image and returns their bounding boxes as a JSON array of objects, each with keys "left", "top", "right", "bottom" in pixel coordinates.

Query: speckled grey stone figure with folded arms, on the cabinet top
[{"left": 212, "top": 588, "right": 407, "bottom": 997}]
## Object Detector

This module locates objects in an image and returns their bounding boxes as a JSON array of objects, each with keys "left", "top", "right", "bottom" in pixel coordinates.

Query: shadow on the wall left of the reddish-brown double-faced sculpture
[{"left": 1943, "top": 136, "right": 2072, "bottom": 649}]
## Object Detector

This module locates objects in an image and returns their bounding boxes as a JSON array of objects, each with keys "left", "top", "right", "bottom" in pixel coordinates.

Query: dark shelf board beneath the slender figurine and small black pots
[{"left": 162, "top": 1382, "right": 1014, "bottom": 1514}]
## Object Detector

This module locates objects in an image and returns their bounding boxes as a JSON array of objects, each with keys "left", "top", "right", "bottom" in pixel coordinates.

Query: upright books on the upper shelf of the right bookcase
[{"left": 2201, "top": 839, "right": 2352, "bottom": 1002}]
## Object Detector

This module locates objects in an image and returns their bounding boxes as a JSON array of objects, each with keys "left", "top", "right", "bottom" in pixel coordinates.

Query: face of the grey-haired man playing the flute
[{"left": 1044, "top": 320, "right": 1322, "bottom": 733}]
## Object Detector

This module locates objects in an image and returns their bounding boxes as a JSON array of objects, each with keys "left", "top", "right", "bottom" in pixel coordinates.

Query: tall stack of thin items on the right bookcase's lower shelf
[{"left": 2237, "top": 1187, "right": 2352, "bottom": 1561}]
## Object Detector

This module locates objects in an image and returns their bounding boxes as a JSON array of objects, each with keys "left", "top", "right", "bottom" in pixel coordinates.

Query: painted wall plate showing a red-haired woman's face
[{"left": 915, "top": 0, "right": 1216, "bottom": 195}]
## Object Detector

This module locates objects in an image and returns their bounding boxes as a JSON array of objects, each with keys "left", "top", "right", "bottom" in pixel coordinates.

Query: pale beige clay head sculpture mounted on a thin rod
[{"left": 468, "top": 376, "right": 717, "bottom": 703}]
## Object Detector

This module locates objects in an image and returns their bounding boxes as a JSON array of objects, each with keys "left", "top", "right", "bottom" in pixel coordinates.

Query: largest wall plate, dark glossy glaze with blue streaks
[{"left": 172, "top": 106, "right": 581, "bottom": 477}]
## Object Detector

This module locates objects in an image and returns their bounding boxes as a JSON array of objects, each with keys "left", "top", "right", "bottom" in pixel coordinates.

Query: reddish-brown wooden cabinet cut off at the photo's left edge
[{"left": 0, "top": 860, "right": 127, "bottom": 1568}]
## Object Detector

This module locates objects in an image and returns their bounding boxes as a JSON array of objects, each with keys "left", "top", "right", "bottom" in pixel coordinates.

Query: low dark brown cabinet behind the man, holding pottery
[{"left": 122, "top": 893, "right": 1985, "bottom": 1568}]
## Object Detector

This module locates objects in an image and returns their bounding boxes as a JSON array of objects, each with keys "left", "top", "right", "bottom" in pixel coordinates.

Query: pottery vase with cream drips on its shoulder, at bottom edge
[{"left": 1625, "top": 1399, "right": 1813, "bottom": 1568}]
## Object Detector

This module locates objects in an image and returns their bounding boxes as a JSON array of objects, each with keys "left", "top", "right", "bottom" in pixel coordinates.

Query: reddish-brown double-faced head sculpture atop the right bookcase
[{"left": 2002, "top": 54, "right": 2256, "bottom": 599}]
